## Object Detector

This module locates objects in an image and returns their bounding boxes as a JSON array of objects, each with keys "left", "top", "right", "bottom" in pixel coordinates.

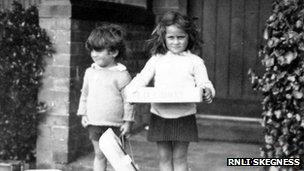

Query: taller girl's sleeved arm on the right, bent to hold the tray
[{"left": 193, "top": 58, "right": 215, "bottom": 98}]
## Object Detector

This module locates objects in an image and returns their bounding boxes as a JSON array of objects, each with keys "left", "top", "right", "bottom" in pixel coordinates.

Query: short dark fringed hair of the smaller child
[{"left": 85, "top": 24, "right": 126, "bottom": 61}]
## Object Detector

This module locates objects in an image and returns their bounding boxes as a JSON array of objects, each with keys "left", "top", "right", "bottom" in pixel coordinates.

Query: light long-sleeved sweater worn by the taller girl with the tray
[{"left": 127, "top": 51, "right": 215, "bottom": 118}]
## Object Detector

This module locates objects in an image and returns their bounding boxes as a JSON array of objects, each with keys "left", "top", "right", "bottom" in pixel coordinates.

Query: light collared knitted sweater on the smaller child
[{"left": 77, "top": 63, "right": 134, "bottom": 126}]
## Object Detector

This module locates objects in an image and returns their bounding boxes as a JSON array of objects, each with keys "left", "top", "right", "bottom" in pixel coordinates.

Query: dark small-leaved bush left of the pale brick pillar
[{"left": 0, "top": 2, "right": 52, "bottom": 161}]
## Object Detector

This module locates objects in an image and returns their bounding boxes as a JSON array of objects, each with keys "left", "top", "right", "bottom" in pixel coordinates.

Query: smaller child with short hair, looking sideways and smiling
[{"left": 77, "top": 24, "right": 134, "bottom": 171}]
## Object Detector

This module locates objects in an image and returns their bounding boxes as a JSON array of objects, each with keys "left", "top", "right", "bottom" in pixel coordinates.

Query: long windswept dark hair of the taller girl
[{"left": 147, "top": 11, "right": 203, "bottom": 55}]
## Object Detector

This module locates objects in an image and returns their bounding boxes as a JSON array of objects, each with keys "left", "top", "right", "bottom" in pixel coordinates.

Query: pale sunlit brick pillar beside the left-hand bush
[{"left": 37, "top": 0, "right": 71, "bottom": 168}]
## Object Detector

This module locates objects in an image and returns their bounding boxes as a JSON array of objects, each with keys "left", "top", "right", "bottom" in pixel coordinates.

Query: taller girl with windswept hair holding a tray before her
[{"left": 128, "top": 11, "right": 215, "bottom": 171}]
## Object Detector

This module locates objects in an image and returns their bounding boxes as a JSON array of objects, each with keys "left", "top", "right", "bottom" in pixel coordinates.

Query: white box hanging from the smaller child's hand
[{"left": 99, "top": 128, "right": 138, "bottom": 171}]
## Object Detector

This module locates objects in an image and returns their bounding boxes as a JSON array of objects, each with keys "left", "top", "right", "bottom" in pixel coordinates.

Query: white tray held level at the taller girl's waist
[{"left": 126, "top": 87, "right": 203, "bottom": 103}]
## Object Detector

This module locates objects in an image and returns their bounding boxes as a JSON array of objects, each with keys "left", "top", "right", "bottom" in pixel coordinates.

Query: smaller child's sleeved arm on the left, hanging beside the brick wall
[{"left": 77, "top": 71, "right": 89, "bottom": 116}]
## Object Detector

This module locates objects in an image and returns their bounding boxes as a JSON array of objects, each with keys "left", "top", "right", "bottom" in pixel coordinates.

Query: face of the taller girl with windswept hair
[{"left": 165, "top": 25, "right": 189, "bottom": 54}]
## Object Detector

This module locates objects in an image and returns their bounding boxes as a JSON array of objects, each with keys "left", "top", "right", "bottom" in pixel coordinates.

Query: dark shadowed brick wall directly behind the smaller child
[{"left": 69, "top": 19, "right": 95, "bottom": 161}]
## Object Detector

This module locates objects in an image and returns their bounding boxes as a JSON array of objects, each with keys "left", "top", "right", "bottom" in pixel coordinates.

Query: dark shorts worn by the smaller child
[{"left": 87, "top": 125, "right": 121, "bottom": 141}]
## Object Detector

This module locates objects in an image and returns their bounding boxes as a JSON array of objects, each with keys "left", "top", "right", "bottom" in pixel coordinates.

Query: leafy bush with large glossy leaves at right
[{"left": 250, "top": 0, "right": 304, "bottom": 169}]
